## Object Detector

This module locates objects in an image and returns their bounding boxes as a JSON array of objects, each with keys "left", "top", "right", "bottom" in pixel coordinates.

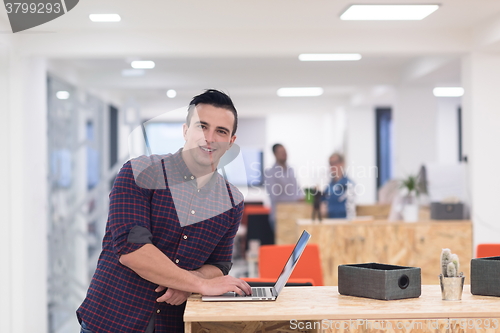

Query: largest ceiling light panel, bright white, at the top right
[{"left": 340, "top": 5, "right": 439, "bottom": 21}]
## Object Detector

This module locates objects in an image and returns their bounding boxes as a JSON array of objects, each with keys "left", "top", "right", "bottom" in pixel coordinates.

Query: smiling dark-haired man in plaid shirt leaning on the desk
[{"left": 77, "top": 90, "right": 251, "bottom": 333}]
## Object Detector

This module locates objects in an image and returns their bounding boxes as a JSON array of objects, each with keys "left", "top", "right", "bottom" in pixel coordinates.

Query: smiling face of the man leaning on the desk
[{"left": 183, "top": 104, "right": 236, "bottom": 172}]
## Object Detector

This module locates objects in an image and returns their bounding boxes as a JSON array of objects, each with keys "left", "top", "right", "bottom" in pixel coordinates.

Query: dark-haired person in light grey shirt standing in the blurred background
[{"left": 264, "top": 143, "right": 304, "bottom": 230}]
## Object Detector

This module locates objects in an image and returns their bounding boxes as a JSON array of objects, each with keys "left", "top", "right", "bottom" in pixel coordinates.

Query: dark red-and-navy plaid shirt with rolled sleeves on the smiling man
[{"left": 77, "top": 151, "right": 243, "bottom": 333}]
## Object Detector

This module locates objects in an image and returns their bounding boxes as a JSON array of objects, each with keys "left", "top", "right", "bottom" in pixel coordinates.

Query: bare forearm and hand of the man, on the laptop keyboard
[{"left": 120, "top": 244, "right": 251, "bottom": 295}]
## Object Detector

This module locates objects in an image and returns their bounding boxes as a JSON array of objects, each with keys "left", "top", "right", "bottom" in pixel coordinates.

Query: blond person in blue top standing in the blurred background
[{"left": 324, "top": 153, "right": 352, "bottom": 218}]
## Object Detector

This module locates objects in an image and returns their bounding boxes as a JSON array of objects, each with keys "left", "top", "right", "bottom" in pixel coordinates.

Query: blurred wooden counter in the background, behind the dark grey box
[{"left": 295, "top": 219, "right": 473, "bottom": 286}]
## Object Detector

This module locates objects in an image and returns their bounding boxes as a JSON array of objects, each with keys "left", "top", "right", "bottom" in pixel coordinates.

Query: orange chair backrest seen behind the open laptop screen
[{"left": 259, "top": 244, "right": 323, "bottom": 286}]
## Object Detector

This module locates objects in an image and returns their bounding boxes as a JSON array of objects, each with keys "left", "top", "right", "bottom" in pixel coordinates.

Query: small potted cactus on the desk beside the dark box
[{"left": 439, "top": 249, "right": 465, "bottom": 301}]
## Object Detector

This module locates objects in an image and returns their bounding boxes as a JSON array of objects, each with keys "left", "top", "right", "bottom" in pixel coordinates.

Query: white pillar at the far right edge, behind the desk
[{"left": 462, "top": 53, "right": 500, "bottom": 245}]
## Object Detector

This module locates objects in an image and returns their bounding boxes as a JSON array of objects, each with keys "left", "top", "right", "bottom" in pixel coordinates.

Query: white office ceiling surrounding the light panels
[{"left": 5, "top": 0, "right": 500, "bottom": 116}]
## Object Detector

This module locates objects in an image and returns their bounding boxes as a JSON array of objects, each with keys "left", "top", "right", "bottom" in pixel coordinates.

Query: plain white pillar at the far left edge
[{"left": 6, "top": 53, "right": 48, "bottom": 333}]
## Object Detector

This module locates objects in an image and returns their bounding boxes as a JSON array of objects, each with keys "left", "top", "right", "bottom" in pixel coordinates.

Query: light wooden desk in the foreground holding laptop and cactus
[{"left": 184, "top": 285, "right": 500, "bottom": 333}]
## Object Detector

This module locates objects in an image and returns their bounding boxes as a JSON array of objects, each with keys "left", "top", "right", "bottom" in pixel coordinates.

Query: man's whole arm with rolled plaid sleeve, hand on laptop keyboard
[{"left": 111, "top": 160, "right": 250, "bottom": 295}]
